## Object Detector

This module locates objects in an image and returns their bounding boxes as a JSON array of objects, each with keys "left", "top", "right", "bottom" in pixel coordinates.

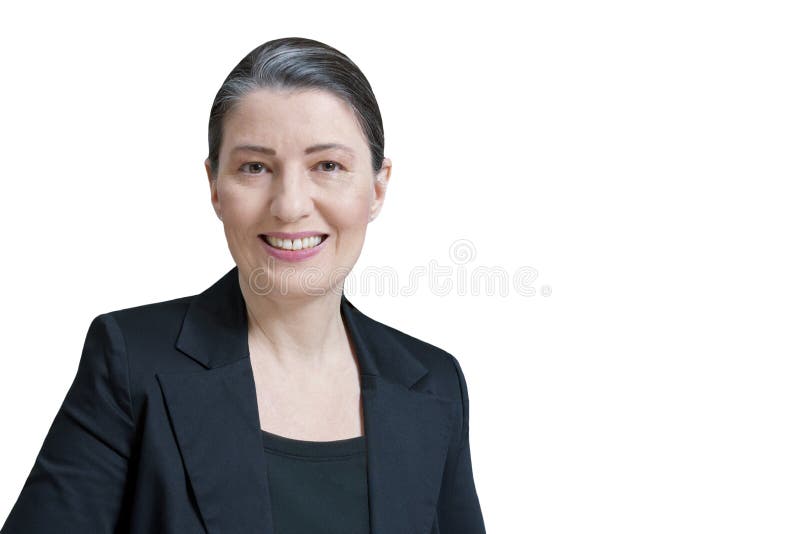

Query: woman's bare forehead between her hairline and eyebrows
[{"left": 223, "top": 89, "right": 368, "bottom": 151}]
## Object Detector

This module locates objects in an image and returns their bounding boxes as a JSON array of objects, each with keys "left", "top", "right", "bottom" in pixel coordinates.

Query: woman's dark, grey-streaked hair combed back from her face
[{"left": 208, "top": 37, "right": 384, "bottom": 177}]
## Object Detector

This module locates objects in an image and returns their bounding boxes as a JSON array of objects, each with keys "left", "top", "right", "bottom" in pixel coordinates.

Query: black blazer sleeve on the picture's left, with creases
[{"left": 0, "top": 314, "right": 134, "bottom": 534}]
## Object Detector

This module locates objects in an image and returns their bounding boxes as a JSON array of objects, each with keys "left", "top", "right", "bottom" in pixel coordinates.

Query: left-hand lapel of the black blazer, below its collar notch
[{"left": 157, "top": 358, "right": 273, "bottom": 534}]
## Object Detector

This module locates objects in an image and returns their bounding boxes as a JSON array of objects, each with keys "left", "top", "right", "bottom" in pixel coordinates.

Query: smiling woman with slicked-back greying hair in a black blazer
[{"left": 2, "top": 38, "right": 485, "bottom": 534}]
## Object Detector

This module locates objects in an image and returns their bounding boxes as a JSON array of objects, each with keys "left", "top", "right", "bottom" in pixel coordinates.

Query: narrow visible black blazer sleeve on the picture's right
[{"left": 437, "top": 355, "right": 486, "bottom": 534}]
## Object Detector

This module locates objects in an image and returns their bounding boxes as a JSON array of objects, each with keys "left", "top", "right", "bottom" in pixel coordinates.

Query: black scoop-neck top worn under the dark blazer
[{"left": 261, "top": 429, "right": 369, "bottom": 534}]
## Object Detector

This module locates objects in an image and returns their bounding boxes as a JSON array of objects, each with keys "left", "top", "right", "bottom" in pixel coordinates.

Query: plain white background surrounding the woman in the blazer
[{"left": 0, "top": 0, "right": 800, "bottom": 534}]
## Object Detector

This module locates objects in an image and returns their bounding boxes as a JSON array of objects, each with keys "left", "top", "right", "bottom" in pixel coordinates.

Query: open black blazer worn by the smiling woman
[{"left": 1, "top": 267, "right": 485, "bottom": 534}]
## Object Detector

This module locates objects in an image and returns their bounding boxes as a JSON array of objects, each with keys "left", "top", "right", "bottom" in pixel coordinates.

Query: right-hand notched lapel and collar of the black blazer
[{"left": 341, "top": 296, "right": 458, "bottom": 534}]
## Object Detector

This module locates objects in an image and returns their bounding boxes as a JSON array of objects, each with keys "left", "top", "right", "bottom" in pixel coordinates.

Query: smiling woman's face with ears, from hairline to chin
[{"left": 206, "top": 89, "right": 391, "bottom": 298}]
